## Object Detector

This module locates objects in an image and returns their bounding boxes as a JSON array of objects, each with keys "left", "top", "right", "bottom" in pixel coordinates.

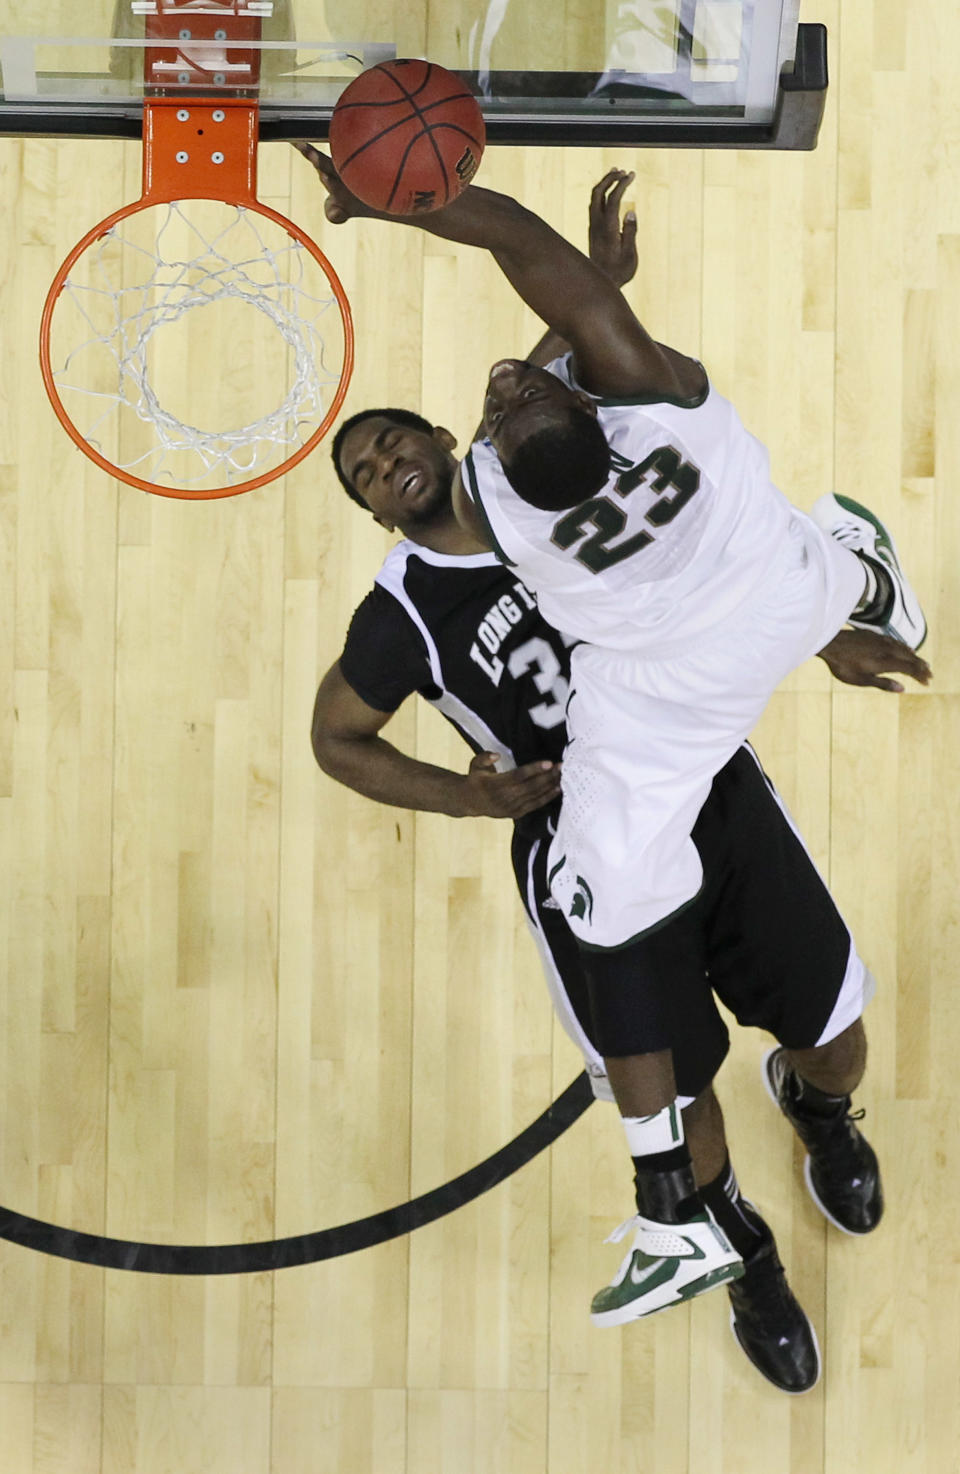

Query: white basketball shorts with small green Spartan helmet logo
[{"left": 549, "top": 513, "right": 864, "bottom": 951}]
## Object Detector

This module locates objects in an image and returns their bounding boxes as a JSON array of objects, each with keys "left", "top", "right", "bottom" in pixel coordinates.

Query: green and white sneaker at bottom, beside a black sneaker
[{"left": 590, "top": 1212, "right": 743, "bottom": 1325}]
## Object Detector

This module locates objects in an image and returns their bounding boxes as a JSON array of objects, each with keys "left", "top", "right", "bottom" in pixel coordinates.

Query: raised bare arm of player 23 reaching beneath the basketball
[{"left": 296, "top": 143, "right": 705, "bottom": 398}]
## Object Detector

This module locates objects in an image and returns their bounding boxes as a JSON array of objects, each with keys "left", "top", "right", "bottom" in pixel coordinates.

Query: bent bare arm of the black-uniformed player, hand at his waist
[{"left": 311, "top": 663, "right": 560, "bottom": 820}]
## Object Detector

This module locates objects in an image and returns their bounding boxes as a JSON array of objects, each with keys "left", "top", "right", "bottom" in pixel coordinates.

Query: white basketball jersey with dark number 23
[{"left": 463, "top": 355, "right": 796, "bottom": 659}]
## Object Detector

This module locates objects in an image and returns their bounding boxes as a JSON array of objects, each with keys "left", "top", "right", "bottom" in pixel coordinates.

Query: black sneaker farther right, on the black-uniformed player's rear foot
[{"left": 764, "top": 1048, "right": 883, "bottom": 1234}]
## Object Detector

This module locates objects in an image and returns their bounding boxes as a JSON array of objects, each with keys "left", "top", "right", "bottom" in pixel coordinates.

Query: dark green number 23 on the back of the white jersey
[{"left": 550, "top": 445, "right": 700, "bottom": 573}]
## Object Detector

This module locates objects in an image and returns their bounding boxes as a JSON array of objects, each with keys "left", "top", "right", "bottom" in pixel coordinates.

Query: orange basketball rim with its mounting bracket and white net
[{"left": 40, "top": 41, "right": 354, "bottom": 500}]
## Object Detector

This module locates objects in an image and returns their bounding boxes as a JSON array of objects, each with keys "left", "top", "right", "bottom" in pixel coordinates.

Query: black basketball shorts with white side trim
[{"left": 513, "top": 744, "right": 869, "bottom": 1097}]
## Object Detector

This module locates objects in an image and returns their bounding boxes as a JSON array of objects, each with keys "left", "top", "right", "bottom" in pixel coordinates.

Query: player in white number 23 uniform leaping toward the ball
[{"left": 299, "top": 144, "right": 925, "bottom": 1315}]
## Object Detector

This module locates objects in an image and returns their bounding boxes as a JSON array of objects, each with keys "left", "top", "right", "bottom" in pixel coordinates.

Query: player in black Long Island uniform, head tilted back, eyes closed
[{"left": 313, "top": 186, "right": 925, "bottom": 1391}]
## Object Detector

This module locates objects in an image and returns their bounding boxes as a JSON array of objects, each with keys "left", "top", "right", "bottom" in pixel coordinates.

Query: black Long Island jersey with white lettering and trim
[{"left": 341, "top": 541, "right": 571, "bottom": 801}]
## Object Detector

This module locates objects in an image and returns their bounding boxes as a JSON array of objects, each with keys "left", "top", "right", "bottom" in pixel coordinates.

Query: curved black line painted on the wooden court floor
[{"left": 0, "top": 1070, "right": 594, "bottom": 1275}]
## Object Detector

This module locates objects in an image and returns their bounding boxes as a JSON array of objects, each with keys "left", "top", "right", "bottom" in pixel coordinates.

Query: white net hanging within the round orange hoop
[{"left": 50, "top": 200, "right": 345, "bottom": 494}]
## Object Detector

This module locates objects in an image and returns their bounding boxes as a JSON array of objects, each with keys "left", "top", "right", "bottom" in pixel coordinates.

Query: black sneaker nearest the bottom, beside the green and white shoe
[{"left": 727, "top": 1235, "right": 820, "bottom": 1394}]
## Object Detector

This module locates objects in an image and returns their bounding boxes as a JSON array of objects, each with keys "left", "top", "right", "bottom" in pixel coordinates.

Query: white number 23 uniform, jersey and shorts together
[{"left": 462, "top": 367, "right": 864, "bottom": 949}]
